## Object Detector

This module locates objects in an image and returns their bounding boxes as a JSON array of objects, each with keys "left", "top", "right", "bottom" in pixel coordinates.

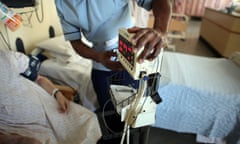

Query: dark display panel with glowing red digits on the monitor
[{"left": 118, "top": 35, "right": 134, "bottom": 66}]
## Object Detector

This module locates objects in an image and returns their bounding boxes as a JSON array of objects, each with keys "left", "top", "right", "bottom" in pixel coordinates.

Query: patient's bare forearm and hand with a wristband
[{"left": 36, "top": 75, "right": 69, "bottom": 113}]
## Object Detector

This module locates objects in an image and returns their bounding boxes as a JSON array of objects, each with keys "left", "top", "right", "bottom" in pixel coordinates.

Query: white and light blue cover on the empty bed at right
[{"left": 154, "top": 52, "right": 240, "bottom": 141}]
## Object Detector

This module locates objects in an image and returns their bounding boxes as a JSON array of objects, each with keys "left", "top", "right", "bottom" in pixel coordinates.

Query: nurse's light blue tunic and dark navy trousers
[{"left": 55, "top": 0, "right": 152, "bottom": 111}]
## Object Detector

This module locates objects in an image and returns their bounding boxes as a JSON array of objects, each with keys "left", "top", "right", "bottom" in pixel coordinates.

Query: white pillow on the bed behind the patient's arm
[{"left": 36, "top": 35, "right": 81, "bottom": 63}]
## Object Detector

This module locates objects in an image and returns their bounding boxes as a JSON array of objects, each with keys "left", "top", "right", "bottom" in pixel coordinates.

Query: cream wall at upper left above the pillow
[{"left": 0, "top": 0, "right": 62, "bottom": 53}]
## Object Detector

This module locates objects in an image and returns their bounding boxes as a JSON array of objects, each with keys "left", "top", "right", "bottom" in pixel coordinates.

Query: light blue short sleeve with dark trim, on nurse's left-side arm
[{"left": 55, "top": 1, "right": 81, "bottom": 40}]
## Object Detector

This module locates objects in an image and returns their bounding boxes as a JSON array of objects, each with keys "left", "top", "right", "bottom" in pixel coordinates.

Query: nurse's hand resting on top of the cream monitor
[{"left": 128, "top": 27, "right": 167, "bottom": 63}]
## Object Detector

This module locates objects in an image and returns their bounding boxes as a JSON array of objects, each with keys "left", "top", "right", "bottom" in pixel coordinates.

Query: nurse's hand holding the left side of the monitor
[{"left": 97, "top": 51, "right": 124, "bottom": 71}]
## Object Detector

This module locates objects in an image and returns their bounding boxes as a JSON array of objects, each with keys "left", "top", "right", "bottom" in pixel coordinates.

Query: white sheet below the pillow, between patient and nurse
[{"left": 40, "top": 57, "right": 98, "bottom": 111}]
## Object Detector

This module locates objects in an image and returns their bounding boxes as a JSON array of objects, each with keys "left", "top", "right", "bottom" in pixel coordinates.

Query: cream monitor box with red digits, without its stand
[{"left": 118, "top": 29, "right": 159, "bottom": 80}]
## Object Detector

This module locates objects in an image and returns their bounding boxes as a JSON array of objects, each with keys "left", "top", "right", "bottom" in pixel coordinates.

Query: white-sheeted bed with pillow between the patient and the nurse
[{"left": 32, "top": 35, "right": 98, "bottom": 111}]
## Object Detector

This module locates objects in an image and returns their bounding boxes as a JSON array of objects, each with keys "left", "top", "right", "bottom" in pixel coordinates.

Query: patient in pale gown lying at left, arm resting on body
[{"left": 0, "top": 49, "right": 101, "bottom": 144}]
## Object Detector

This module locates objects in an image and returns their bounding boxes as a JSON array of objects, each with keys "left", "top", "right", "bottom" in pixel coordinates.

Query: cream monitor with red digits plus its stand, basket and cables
[{"left": 110, "top": 29, "right": 163, "bottom": 144}]
